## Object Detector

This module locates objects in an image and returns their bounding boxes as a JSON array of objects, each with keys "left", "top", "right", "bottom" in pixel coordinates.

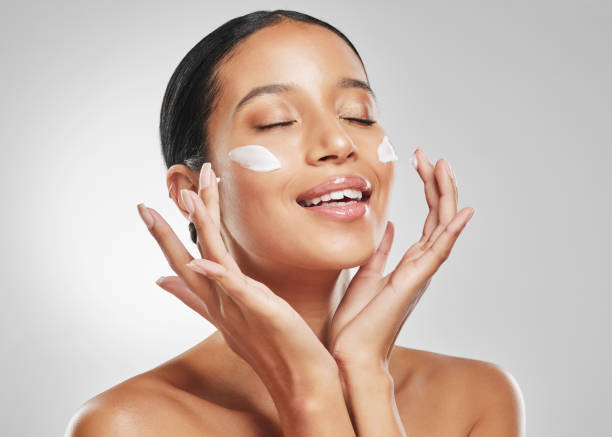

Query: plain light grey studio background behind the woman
[{"left": 0, "top": 0, "right": 612, "bottom": 436}]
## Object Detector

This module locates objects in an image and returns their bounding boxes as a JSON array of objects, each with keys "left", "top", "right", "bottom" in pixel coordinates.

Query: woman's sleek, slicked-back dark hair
[{"left": 159, "top": 9, "right": 367, "bottom": 243}]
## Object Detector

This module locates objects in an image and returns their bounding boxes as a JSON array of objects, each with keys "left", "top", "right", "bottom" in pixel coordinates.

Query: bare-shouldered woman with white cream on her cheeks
[{"left": 67, "top": 10, "right": 523, "bottom": 437}]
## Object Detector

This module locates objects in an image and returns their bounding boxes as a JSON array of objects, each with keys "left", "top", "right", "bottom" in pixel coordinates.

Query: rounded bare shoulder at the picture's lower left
[{"left": 65, "top": 375, "right": 201, "bottom": 437}]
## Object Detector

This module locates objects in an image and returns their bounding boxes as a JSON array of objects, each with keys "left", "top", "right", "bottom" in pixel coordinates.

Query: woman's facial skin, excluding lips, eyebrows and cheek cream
[{"left": 208, "top": 22, "right": 395, "bottom": 270}]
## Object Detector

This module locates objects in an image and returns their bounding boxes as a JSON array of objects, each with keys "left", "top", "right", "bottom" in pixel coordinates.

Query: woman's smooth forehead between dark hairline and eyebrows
[{"left": 219, "top": 21, "right": 367, "bottom": 110}]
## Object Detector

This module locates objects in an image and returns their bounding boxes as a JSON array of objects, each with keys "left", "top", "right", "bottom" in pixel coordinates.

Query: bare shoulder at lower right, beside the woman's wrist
[{"left": 394, "top": 346, "right": 525, "bottom": 437}]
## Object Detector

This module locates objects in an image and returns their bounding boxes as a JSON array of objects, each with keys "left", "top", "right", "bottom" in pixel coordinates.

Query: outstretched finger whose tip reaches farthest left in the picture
[{"left": 138, "top": 203, "right": 217, "bottom": 316}]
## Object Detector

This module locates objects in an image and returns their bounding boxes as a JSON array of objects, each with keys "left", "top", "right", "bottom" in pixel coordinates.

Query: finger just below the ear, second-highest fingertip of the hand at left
[{"left": 180, "top": 190, "right": 240, "bottom": 272}]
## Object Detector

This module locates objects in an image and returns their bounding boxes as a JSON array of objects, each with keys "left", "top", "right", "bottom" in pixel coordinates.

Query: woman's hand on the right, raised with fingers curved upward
[{"left": 327, "top": 149, "right": 475, "bottom": 370}]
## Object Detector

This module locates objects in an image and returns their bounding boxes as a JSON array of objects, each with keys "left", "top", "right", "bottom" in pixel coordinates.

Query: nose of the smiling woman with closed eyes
[{"left": 307, "top": 114, "right": 357, "bottom": 165}]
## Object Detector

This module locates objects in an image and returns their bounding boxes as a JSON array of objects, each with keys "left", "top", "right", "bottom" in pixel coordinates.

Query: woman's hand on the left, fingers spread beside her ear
[{"left": 138, "top": 164, "right": 337, "bottom": 400}]
